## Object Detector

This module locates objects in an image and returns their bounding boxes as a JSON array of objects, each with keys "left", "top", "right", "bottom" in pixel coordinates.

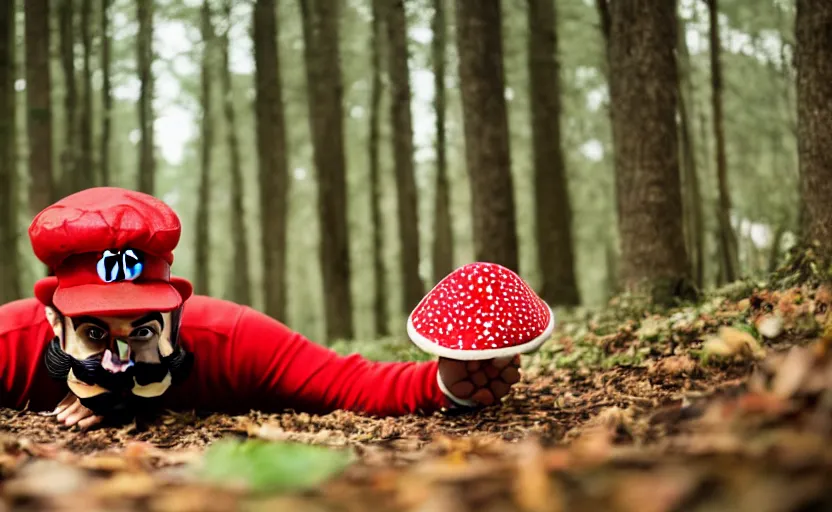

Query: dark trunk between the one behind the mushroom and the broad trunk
[{"left": 527, "top": 0, "right": 581, "bottom": 306}]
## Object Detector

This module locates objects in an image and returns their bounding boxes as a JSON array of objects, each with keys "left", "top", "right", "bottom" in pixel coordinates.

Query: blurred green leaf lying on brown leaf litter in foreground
[{"left": 199, "top": 439, "right": 354, "bottom": 492}]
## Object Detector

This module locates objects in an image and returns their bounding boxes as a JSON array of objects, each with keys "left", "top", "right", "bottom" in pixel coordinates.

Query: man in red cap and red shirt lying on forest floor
[{"left": 0, "top": 187, "right": 551, "bottom": 428}]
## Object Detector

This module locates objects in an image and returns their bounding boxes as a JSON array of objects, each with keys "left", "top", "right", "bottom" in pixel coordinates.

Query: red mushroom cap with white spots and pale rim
[{"left": 407, "top": 263, "right": 555, "bottom": 360}]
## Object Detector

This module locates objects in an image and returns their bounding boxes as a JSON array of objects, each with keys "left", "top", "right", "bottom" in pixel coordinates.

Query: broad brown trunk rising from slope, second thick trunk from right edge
[{"left": 609, "top": 0, "right": 691, "bottom": 304}]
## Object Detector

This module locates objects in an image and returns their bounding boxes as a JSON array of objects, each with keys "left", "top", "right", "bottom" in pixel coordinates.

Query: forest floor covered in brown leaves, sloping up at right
[{"left": 0, "top": 268, "right": 832, "bottom": 512}]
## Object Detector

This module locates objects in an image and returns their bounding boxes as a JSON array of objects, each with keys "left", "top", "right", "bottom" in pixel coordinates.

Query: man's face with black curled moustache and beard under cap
[{"left": 47, "top": 309, "right": 192, "bottom": 416}]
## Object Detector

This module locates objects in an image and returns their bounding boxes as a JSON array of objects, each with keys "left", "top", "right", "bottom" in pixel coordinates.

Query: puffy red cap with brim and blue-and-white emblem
[{"left": 29, "top": 187, "right": 193, "bottom": 316}]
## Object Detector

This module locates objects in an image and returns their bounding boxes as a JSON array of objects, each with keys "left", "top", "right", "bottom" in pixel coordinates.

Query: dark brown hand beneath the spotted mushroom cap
[{"left": 439, "top": 355, "right": 520, "bottom": 406}]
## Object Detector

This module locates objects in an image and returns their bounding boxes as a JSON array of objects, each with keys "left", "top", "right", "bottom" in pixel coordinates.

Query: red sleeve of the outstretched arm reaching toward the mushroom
[{"left": 224, "top": 308, "right": 450, "bottom": 416}]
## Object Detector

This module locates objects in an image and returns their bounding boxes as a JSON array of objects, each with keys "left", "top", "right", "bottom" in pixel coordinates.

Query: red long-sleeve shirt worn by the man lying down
[{"left": 0, "top": 296, "right": 450, "bottom": 416}]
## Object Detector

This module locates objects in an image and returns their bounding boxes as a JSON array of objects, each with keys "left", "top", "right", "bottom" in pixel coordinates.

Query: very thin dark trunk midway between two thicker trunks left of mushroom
[{"left": 368, "top": 0, "right": 390, "bottom": 337}]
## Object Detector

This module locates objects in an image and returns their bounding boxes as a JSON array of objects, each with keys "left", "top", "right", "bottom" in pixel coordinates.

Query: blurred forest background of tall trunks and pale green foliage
[{"left": 0, "top": 0, "right": 832, "bottom": 342}]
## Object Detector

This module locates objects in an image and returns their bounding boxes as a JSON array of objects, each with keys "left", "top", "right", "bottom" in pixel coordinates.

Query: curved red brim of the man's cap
[{"left": 35, "top": 277, "right": 193, "bottom": 316}]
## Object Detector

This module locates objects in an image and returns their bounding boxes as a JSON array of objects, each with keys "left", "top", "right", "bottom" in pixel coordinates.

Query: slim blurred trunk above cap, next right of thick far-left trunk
[{"left": 58, "top": 0, "right": 81, "bottom": 196}]
